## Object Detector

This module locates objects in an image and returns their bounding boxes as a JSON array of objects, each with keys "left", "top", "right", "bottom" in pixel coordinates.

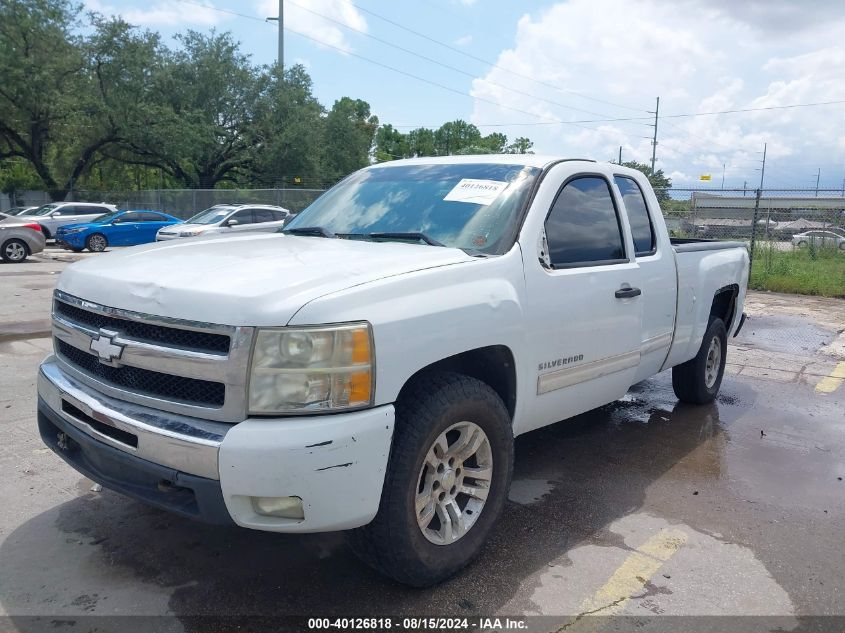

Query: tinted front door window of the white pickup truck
[{"left": 546, "top": 176, "right": 625, "bottom": 266}]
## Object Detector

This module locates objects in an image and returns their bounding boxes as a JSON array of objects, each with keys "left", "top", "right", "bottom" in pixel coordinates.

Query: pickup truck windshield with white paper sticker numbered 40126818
[{"left": 284, "top": 163, "right": 540, "bottom": 253}]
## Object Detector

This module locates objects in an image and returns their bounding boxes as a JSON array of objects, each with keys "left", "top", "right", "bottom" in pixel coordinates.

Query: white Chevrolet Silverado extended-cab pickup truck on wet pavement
[{"left": 38, "top": 155, "right": 749, "bottom": 586}]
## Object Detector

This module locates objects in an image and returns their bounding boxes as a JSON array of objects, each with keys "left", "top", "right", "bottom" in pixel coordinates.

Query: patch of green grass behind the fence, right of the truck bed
[{"left": 748, "top": 242, "right": 845, "bottom": 298}]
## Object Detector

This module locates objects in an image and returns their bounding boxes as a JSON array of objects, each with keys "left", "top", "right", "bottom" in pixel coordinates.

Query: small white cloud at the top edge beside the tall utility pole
[{"left": 257, "top": 0, "right": 367, "bottom": 49}]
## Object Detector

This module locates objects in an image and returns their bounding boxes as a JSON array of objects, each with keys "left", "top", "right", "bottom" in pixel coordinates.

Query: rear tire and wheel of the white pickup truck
[{"left": 672, "top": 319, "right": 728, "bottom": 404}]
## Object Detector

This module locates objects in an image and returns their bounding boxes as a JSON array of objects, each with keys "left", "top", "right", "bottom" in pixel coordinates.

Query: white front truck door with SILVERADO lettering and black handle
[{"left": 520, "top": 170, "right": 643, "bottom": 430}]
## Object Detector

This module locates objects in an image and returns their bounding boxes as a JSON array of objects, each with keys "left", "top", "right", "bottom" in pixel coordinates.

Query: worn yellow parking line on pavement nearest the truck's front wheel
[{"left": 564, "top": 529, "right": 687, "bottom": 628}]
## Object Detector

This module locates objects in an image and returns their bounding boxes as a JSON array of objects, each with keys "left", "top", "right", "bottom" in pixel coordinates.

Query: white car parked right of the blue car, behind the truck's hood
[{"left": 156, "top": 204, "right": 291, "bottom": 242}]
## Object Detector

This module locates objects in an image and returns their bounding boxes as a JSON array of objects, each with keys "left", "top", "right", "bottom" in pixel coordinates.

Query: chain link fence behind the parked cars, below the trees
[{"left": 67, "top": 188, "right": 325, "bottom": 220}]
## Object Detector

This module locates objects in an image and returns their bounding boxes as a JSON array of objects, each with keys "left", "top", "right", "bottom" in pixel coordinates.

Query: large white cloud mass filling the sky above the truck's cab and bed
[{"left": 471, "top": 0, "right": 845, "bottom": 186}]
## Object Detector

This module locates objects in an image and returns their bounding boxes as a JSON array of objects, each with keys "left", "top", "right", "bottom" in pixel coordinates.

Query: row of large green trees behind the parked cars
[{"left": 0, "top": 0, "right": 532, "bottom": 199}]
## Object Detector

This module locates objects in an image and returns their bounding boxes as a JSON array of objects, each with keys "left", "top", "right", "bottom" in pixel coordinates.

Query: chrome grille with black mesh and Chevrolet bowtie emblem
[{"left": 53, "top": 290, "right": 253, "bottom": 422}]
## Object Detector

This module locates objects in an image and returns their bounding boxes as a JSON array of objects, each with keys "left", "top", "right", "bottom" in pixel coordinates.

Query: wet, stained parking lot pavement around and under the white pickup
[{"left": 0, "top": 253, "right": 845, "bottom": 631}]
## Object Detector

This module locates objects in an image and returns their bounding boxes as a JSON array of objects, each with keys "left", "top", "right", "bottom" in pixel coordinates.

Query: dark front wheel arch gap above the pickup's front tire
[{"left": 398, "top": 345, "right": 517, "bottom": 421}]
